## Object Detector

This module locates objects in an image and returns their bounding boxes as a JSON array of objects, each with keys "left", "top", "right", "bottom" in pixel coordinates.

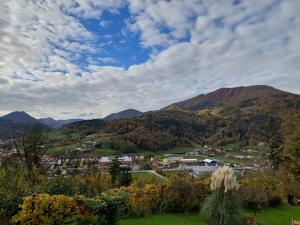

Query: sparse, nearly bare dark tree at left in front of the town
[{"left": 13, "top": 125, "right": 47, "bottom": 171}]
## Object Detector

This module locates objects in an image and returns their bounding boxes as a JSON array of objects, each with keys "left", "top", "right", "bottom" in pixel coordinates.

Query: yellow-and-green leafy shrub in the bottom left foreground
[{"left": 12, "top": 192, "right": 126, "bottom": 225}]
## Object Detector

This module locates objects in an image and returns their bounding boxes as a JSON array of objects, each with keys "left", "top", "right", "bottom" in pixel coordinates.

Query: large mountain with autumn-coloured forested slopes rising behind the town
[{"left": 62, "top": 85, "right": 300, "bottom": 152}]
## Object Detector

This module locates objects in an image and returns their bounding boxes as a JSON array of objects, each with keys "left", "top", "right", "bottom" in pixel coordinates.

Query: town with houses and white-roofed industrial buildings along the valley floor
[{"left": 0, "top": 139, "right": 268, "bottom": 178}]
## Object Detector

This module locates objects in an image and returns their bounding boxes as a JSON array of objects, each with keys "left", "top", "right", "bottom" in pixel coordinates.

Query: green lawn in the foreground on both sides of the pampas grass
[{"left": 120, "top": 206, "right": 300, "bottom": 225}]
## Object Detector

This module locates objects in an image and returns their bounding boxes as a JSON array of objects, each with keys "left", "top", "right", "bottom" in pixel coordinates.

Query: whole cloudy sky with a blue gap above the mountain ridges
[{"left": 0, "top": 0, "right": 300, "bottom": 119}]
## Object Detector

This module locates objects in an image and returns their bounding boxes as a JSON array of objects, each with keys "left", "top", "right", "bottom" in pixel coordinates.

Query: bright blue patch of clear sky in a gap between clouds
[{"left": 78, "top": 6, "right": 151, "bottom": 69}]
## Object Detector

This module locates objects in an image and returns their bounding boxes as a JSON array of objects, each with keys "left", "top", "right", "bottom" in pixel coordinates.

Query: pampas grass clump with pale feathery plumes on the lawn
[{"left": 202, "top": 166, "right": 243, "bottom": 225}]
